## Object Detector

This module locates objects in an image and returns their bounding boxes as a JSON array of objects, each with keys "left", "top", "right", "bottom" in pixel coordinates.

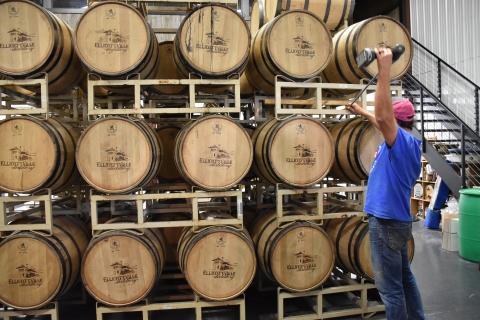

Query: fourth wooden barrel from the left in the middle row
[{"left": 252, "top": 116, "right": 334, "bottom": 188}]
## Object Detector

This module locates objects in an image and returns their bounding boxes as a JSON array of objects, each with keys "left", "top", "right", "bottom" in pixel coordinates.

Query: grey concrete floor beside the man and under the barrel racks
[{"left": 14, "top": 221, "right": 480, "bottom": 320}]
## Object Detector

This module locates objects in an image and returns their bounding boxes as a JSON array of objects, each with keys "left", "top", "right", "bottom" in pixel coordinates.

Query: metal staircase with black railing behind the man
[{"left": 402, "top": 40, "right": 480, "bottom": 198}]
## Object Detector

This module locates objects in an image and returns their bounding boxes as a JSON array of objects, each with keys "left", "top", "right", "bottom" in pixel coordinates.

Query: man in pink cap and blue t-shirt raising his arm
[{"left": 346, "top": 48, "right": 425, "bottom": 320}]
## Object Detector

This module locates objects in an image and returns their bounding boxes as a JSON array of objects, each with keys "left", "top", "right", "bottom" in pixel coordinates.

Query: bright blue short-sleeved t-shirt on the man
[{"left": 363, "top": 127, "right": 422, "bottom": 221}]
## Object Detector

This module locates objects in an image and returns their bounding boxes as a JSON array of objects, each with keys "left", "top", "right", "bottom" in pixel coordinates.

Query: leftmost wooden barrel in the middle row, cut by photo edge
[{"left": 0, "top": 116, "right": 79, "bottom": 193}]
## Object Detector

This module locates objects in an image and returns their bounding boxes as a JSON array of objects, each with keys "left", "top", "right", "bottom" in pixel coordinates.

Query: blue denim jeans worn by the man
[{"left": 369, "top": 215, "right": 426, "bottom": 320}]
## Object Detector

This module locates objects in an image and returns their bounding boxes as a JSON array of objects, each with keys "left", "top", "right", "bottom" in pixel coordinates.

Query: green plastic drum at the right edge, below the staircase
[{"left": 458, "top": 188, "right": 480, "bottom": 262}]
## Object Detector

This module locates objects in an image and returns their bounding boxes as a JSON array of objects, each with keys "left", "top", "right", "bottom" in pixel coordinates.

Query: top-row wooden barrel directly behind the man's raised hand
[{"left": 320, "top": 16, "right": 413, "bottom": 96}]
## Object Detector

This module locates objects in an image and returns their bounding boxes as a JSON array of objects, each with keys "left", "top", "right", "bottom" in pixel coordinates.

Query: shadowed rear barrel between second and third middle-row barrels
[{"left": 155, "top": 123, "right": 182, "bottom": 182}]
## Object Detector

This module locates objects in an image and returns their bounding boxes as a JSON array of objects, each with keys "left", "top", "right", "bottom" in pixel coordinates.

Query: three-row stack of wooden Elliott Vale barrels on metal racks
[{"left": 0, "top": 0, "right": 413, "bottom": 309}]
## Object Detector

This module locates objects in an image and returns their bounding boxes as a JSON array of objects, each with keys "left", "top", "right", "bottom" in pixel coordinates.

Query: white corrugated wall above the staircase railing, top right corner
[{"left": 410, "top": 0, "right": 480, "bottom": 85}]
